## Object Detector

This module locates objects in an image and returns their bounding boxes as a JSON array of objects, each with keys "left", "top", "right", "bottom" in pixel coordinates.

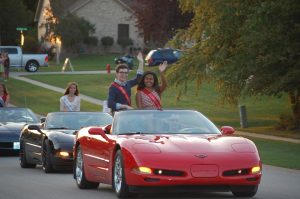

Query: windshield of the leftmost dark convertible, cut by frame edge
[{"left": 0, "top": 108, "right": 39, "bottom": 123}]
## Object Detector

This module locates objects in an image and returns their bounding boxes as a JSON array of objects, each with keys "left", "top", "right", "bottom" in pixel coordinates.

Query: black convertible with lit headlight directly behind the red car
[{"left": 20, "top": 112, "right": 112, "bottom": 173}]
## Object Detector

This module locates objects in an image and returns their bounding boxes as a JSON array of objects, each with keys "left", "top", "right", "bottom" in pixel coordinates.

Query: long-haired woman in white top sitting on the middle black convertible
[{"left": 59, "top": 82, "right": 80, "bottom": 111}]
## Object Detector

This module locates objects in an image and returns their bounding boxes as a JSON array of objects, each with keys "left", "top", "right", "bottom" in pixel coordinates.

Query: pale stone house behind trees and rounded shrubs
[{"left": 35, "top": 0, "right": 144, "bottom": 52}]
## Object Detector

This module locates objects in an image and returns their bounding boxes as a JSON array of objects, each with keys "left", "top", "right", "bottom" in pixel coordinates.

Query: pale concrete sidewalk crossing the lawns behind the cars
[{"left": 10, "top": 71, "right": 300, "bottom": 144}]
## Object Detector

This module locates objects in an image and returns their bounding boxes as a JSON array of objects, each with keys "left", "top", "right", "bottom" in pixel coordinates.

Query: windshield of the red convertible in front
[{"left": 113, "top": 110, "right": 220, "bottom": 134}]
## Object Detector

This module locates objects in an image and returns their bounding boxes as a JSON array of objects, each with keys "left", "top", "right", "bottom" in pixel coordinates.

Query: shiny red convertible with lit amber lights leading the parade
[{"left": 73, "top": 110, "right": 262, "bottom": 197}]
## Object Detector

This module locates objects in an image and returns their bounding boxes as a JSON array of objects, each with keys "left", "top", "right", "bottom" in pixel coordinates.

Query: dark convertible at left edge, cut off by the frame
[{"left": 0, "top": 107, "right": 39, "bottom": 154}]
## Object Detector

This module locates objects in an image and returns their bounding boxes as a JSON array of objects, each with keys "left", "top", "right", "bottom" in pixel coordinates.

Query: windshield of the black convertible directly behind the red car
[{"left": 45, "top": 112, "right": 112, "bottom": 130}]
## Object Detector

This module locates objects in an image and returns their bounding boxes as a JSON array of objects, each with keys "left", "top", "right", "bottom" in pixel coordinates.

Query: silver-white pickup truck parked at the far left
[{"left": 0, "top": 46, "right": 48, "bottom": 72}]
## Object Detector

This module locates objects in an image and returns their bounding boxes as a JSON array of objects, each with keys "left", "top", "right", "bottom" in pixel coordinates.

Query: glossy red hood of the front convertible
[{"left": 122, "top": 134, "right": 256, "bottom": 153}]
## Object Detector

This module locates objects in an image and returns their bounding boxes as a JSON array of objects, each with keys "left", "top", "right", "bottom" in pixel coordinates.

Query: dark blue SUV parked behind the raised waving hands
[{"left": 145, "top": 48, "right": 182, "bottom": 66}]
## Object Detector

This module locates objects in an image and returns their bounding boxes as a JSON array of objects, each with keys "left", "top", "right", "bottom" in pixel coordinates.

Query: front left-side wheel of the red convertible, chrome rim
[{"left": 112, "top": 150, "right": 130, "bottom": 198}]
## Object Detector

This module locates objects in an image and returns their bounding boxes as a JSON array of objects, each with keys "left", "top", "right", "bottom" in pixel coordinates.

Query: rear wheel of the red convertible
[{"left": 74, "top": 146, "right": 99, "bottom": 189}]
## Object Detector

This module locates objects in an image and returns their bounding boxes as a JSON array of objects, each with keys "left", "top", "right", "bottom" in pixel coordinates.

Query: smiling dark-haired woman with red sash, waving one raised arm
[{"left": 136, "top": 61, "right": 168, "bottom": 109}]
